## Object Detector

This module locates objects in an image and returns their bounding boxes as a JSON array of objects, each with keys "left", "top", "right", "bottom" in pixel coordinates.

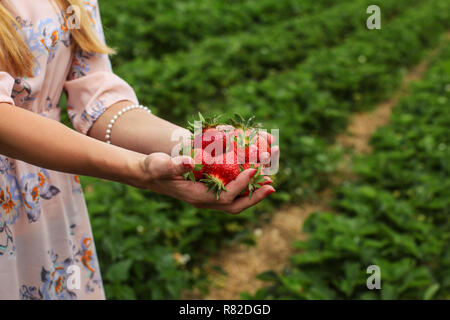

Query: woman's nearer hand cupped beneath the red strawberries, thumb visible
[{"left": 135, "top": 153, "right": 275, "bottom": 214}]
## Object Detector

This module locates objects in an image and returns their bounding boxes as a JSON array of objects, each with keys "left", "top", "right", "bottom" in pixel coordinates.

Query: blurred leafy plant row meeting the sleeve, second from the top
[{"left": 116, "top": 0, "right": 422, "bottom": 120}]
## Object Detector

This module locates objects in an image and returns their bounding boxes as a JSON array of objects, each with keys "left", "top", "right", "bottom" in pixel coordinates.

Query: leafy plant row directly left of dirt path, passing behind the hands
[{"left": 83, "top": 0, "right": 448, "bottom": 298}]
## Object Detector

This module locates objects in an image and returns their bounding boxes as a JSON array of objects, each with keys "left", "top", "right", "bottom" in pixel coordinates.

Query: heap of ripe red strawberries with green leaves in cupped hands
[{"left": 184, "top": 113, "right": 271, "bottom": 199}]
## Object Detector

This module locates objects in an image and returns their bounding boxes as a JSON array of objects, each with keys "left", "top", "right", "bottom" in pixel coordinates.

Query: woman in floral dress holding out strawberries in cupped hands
[{"left": 0, "top": 0, "right": 275, "bottom": 299}]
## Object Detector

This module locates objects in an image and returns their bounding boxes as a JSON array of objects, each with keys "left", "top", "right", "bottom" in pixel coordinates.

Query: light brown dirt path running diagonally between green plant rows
[{"left": 184, "top": 34, "right": 450, "bottom": 299}]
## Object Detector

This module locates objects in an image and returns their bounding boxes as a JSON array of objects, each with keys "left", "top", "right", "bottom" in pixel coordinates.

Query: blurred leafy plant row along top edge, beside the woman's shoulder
[{"left": 102, "top": 0, "right": 335, "bottom": 63}]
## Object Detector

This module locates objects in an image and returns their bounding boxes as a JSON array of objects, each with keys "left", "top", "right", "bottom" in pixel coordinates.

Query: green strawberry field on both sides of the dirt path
[{"left": 67, "top": 0, "right": 450, "bottom": 299}]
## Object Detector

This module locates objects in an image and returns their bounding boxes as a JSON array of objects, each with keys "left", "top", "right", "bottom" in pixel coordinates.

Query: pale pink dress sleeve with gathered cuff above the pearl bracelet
[{"left": 64, "top": 0, "right": 138, "bottom": 134}]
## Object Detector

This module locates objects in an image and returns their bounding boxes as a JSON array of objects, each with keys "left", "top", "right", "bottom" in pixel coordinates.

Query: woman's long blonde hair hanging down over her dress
[{"left": 0, "top": 0, "right": 114, "bottom": 77}]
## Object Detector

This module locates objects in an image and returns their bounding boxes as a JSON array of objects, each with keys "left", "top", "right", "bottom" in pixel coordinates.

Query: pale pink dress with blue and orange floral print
[{"left": 0, "top": 0, "right": 138, "bottom": 299}]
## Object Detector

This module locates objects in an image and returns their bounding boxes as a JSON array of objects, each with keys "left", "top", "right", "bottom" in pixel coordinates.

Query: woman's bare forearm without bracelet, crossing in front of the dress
[{"left": 0, "top": 103, "right": 144, "bottom": 188}]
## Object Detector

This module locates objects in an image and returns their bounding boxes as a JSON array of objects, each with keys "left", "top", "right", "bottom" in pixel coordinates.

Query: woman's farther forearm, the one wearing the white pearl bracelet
[{"left": 88, "top": 101, "right": 192, "bottom": 154}]
